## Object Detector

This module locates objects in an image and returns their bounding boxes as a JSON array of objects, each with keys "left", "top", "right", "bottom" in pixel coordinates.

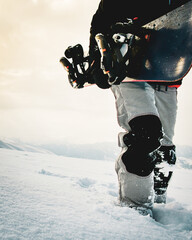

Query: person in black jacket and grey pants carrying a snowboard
[{"left": 89, "top": 0, "right": 190, "bottom": 212}]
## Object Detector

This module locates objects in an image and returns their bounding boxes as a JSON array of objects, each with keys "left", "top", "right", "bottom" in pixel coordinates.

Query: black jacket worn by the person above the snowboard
[{"left": 90, "top": 0, "right": 190, "bottom": 37}]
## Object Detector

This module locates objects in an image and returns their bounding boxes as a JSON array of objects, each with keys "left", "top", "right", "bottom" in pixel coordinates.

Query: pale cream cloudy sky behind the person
[{"left": 0, "top": 0, "right": 192, "bottom": 145}]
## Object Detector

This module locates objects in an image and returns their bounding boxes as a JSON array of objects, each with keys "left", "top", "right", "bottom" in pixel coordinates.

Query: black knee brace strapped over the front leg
[{"left": 122, "top": 115, "right": 163, "bottom": 176}]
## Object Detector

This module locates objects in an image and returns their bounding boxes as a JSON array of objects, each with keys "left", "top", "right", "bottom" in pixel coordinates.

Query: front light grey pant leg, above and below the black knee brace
[{"left": 112, "top": 82, "right": 159, "bottom": 208}]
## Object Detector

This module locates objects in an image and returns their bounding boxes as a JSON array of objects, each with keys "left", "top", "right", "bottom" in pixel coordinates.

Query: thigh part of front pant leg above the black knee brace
[{"left": 111, "top": 82, "right": 159, "bottom": 131}]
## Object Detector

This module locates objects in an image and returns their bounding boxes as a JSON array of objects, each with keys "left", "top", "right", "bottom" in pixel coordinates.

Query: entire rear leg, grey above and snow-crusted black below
[{"left": 154, "top": 86, "right": 177, "bottom": 203}]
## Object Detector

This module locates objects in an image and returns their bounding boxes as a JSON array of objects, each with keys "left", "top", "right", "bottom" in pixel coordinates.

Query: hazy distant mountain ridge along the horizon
[{"left": 0, "top": 139, "right": 192, "bottom": 161}]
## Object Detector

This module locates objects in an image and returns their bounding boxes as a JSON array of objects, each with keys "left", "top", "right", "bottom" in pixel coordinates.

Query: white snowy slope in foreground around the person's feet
[{"left": 0, "top": 148, "right": 192, "bottom": 240}]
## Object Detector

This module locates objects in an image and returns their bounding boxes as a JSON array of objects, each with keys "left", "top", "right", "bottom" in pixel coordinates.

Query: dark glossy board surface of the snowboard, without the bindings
[{"left": 123, "top": 1, "right": 192, "bottom": 82}]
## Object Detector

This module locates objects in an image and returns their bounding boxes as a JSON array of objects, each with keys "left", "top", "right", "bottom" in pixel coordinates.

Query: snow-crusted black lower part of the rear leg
[{"left": 154, "top": 146, "right": 176, "bottom": 203}]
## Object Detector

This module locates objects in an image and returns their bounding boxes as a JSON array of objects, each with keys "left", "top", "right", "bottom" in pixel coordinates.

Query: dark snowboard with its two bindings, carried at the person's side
[{"left": 60, "top": 0, "right": 192, "bottom": 88}]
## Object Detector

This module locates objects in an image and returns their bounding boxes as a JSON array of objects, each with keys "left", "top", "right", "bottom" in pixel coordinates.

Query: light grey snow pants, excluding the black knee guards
[{"left": 111, "top": 82, "right": 177, "bottom": 208}]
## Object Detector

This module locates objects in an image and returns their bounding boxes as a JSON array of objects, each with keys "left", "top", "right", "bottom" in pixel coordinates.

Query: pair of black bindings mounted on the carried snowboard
[{"left": 60, "top": 26, "right": 139, "bottom": 89}]
